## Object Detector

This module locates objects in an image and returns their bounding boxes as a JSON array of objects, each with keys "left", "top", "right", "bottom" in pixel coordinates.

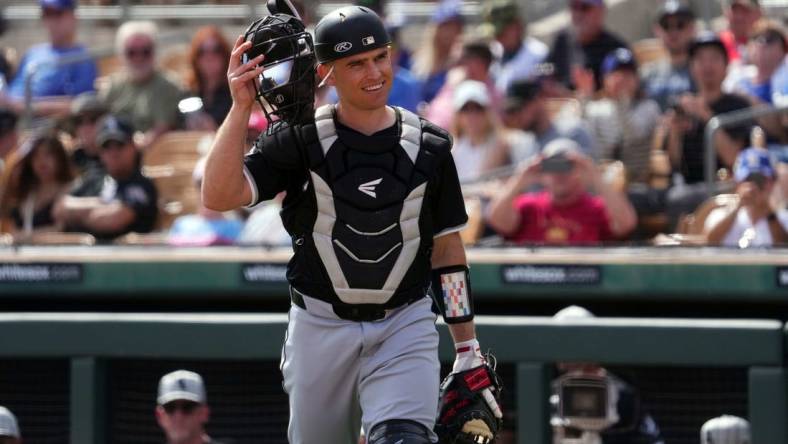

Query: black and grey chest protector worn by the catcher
[{"left": 307, "top": 105, "right": 436, "bottom": 305}]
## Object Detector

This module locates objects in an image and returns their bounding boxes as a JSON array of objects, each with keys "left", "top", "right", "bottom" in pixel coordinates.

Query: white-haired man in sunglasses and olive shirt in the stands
[{"left": 101, "top": 21, "right": 183, "bottom": 149}]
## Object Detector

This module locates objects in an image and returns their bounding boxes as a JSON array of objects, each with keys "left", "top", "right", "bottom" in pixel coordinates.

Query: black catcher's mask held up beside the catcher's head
[{"left": 243, "top": 6, "right": 315, "bottom": 133}]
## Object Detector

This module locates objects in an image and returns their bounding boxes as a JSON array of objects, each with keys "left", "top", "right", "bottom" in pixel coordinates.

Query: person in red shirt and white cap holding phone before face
[{"left": 487, "top": 138, "right": 637, "bottom": 245}]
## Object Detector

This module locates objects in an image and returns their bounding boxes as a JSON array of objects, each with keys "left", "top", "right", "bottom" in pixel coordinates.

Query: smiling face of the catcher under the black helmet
[{"left": 331, "top": 48, "right": 394, "bottom": 111}]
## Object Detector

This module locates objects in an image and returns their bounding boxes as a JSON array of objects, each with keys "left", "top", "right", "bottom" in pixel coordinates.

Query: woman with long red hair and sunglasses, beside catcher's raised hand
[{"left": 186, "top": 25, "right": 233, "bottom": 130}]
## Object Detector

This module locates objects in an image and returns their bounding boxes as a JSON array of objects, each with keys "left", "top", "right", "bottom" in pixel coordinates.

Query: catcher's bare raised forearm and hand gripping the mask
[{"left": 202, "top": 36, "right": 263, "bottom": 211}]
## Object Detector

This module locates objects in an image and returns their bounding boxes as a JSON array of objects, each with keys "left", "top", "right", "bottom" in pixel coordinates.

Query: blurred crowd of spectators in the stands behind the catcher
[{"left": 0, "top": 0, "right": 788, "bottom": 246}]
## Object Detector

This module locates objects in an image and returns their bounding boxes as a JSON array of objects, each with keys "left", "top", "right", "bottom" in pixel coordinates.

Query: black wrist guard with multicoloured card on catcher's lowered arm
[{"left": 432, "top": 265, "right": 473, "bottom": 324}]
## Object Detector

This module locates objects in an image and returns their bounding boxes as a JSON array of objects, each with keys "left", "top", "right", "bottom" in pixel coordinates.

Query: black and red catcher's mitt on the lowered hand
[{"left": 435, "top": 355, "right": 503, "bottom": 444}]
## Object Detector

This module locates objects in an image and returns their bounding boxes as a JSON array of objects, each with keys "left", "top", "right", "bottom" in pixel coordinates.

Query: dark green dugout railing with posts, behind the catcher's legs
[{"left": 0, "top": 313, "right": 788, "bottom": 444}]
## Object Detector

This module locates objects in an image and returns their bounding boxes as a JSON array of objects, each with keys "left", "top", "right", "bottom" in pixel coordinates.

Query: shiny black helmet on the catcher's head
[{"left": 315, "top": 6, "right": 391, "bottom": 63}]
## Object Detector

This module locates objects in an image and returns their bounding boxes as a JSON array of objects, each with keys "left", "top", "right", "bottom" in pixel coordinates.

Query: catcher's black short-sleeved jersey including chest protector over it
[{"left": 244, "top": 107, "right": 467, "bottom": 307}]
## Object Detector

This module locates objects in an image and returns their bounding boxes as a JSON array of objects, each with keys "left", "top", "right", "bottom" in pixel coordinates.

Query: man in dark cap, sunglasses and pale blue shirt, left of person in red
[{"left": 642, "top": 0, "right": 696, "bottom": 112}]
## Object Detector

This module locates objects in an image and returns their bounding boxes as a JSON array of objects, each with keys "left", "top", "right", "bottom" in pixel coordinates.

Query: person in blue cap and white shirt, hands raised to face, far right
[{"left": 704, "top": 148, "right": 788, "bottom": 248}]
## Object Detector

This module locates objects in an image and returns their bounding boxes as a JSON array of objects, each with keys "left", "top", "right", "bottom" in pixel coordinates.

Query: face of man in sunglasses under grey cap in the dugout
[{"left": 156, "top": 401, "right": 209, "bottom": 444}]
